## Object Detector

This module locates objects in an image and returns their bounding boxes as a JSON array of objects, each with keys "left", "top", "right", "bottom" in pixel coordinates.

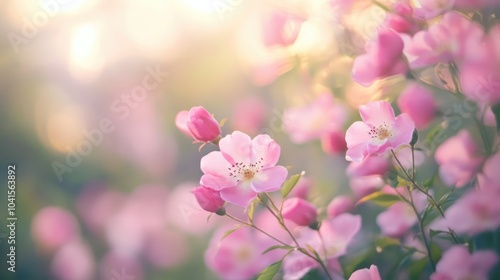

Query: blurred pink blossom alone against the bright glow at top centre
[{"left": 262, "top": 11, "right": 305, "bottom": 47}]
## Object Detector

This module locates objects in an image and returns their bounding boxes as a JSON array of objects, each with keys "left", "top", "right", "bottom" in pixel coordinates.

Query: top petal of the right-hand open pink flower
[{"left": 359, "top": 101, "right": 395, "bottom": 129}]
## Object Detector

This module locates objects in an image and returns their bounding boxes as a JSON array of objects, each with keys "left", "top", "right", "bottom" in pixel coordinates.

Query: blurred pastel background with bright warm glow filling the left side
[{"left": 0, "top": 0, "right": 374, "bottom": 280}]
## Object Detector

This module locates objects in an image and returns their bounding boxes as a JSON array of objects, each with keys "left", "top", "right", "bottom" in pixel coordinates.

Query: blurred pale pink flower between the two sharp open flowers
[{"left": 283, "top": 92, "right": 347, "bottom": 144}]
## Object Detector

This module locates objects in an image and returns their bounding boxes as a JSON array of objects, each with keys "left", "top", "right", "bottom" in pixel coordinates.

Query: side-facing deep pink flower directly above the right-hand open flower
[{"left": 352, "top": 29, "right": 408, "bottom": 86}]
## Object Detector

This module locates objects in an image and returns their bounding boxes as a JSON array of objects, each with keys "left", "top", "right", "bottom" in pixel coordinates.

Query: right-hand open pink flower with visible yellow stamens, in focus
[{"left": 345, "top": 101, "right": 415, "bottom": 162}]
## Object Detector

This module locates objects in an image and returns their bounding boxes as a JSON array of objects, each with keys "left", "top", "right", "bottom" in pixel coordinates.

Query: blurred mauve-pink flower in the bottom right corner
[{"left": 431, "top": 245, "right": 498, "bottom": 280}]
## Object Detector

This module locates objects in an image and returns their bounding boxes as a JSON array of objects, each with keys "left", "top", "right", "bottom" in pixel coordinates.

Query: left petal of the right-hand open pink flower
[{"left": 345, "top": 121, "right": 372, "bottom": 162}]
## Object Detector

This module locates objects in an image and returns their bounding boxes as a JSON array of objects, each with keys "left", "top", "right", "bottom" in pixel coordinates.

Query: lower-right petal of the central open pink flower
[{"left": 252, "top": 165, "right": 288, "bottom": 192}]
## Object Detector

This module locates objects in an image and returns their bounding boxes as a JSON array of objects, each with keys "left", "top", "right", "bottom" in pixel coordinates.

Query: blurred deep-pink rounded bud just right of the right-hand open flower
[{"left": 398, "top": 82, "right": 436, "bottom": 129}]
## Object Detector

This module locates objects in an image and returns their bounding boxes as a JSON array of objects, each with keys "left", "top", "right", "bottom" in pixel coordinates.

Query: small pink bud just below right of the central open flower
[{"left": 282, "top": 197, "right": 318, "bottom": 226}]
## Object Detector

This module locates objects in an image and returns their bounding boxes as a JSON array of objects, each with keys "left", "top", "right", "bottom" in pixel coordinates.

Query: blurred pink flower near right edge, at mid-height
[{"left": 434, "top": 130, "right": 483, "bottom": 187}]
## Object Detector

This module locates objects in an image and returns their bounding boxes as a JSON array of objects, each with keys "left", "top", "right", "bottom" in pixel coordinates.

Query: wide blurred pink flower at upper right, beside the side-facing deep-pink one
[{"left": 405, "top": 12, "right": 484, "bottom": 68}]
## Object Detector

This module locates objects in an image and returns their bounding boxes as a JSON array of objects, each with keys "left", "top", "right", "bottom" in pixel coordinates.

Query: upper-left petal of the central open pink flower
[{"left": 219, "top": 131, "right": 252, "bottom": 164}]
